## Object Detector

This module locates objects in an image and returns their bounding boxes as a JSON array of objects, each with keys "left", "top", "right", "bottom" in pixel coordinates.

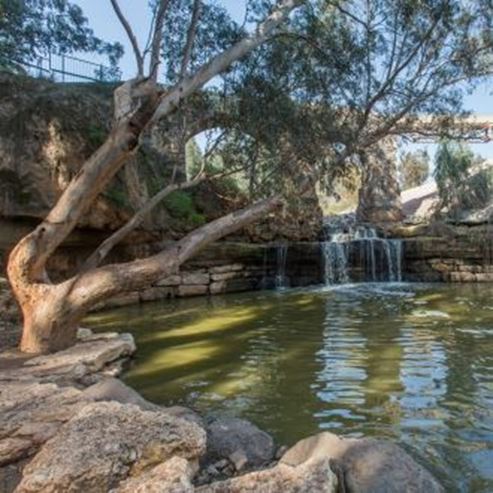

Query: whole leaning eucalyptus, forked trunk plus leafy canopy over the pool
[{"left": 8, "top": 0, "right": 492, "bottom": 352}]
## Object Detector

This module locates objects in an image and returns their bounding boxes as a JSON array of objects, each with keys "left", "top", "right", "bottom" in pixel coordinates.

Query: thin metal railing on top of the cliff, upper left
[{"left": 10, "top": 53, "right": 121, "bottom": 82}]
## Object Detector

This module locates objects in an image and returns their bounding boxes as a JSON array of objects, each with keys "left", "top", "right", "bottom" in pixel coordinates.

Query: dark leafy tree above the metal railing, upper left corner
[{"left": 0, "top": 0, "right": 123, "bottom": 70}]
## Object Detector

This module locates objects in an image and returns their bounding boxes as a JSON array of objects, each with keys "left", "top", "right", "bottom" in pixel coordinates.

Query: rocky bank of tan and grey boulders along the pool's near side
[{"left": 0, "top": 330, "right": 443, "bottom": 493}]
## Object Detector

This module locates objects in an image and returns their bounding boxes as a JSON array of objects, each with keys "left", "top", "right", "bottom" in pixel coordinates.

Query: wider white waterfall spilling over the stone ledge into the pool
[{"left": 321, "top": 226, "right": 402, "bottom": 285}]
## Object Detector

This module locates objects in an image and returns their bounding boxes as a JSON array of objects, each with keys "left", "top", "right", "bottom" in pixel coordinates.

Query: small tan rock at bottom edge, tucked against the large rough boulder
[{"left": 112, "top": 457, "right": 194, "bottom": 493}]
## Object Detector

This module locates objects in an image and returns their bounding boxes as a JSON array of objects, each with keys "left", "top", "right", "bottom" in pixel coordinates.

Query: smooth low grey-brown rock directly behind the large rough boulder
[{"left": 81, "top": 378, "right": 162, "bottom": 411}]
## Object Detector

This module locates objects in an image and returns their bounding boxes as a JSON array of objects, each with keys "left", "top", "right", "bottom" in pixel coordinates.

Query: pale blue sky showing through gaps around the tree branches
[{"left": 74, "top": 0, "right": 493, "bottom": 159}]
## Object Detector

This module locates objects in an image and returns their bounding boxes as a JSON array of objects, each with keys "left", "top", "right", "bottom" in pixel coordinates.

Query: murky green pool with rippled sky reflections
[{"left": 88, "top": 283, "right": 493, "bottom": 492}]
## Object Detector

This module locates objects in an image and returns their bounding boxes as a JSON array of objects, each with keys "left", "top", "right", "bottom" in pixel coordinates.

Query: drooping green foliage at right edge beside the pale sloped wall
[{"left": 434, "top": 141, "right": 493, "bottom": 216}]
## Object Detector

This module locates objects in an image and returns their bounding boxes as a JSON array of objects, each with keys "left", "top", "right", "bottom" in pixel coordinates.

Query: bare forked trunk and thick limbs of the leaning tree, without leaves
[{"left": 7, "top": 0, "right": 302, "bottom": 353}]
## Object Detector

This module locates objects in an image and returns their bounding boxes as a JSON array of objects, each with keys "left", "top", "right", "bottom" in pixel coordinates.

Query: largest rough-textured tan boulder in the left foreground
[{"left": 16, "top": 402, "right": 205, "bottom": 493}]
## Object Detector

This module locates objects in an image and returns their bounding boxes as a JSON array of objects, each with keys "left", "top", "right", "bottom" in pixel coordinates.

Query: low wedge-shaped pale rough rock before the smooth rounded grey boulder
[{"left": 195, "top": 458, "right": 337, "bottom": 493}]
